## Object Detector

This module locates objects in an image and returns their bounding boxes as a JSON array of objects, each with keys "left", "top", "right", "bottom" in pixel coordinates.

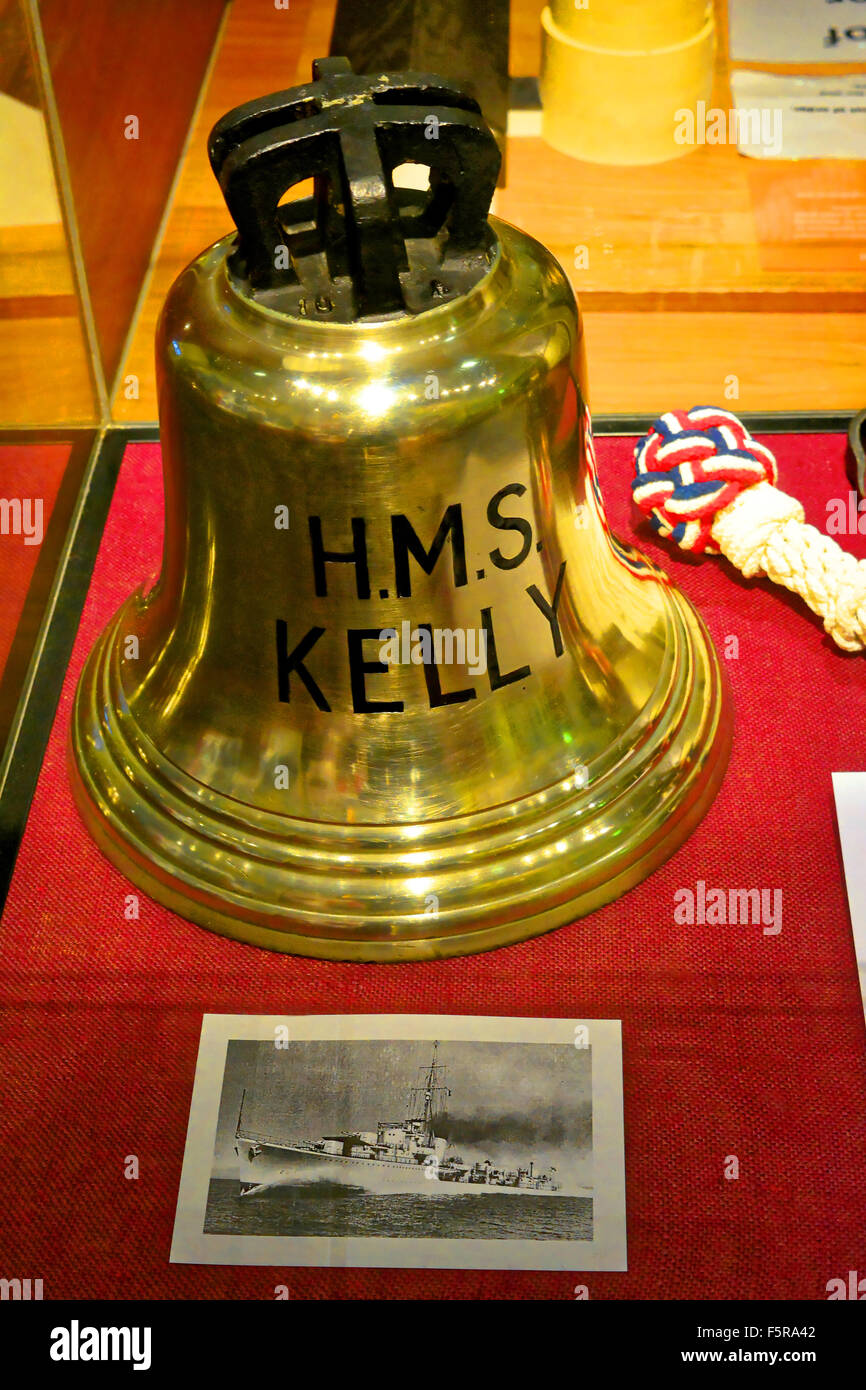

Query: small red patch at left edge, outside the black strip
[{"left": 0, "top": 443, "right": 70, "bottom": 680}]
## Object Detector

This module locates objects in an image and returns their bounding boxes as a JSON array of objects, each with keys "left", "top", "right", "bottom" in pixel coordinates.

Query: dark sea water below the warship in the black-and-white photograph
[{"left": 204, "top": 1179, "right": 592, "bottom": 1240}]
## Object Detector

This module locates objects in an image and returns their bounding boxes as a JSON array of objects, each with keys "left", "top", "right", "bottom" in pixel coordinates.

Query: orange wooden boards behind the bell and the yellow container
[{"left": 114, "top": 0, "right": 866, "bottom": 420}]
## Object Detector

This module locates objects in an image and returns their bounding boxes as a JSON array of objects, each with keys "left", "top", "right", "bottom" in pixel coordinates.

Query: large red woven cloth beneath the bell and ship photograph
[{"left": 0, "top": 436, "right": 866, "bottom": 1298}]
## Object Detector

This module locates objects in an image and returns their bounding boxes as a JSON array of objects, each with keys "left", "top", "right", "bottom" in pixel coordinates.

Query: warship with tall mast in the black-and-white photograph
[{"left": 235, "top": 1043, "right": 592, "bottom": 1197}]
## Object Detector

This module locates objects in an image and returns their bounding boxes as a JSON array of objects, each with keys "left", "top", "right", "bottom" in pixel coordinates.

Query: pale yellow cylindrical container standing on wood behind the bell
[{"left": 541, "top": 0, "right": 714, "bottom": 164}]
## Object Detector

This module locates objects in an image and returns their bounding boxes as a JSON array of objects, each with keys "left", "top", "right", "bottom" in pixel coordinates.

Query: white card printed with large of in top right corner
[{"left": 728, "top": 0, "right": 866, "bottom": 63}]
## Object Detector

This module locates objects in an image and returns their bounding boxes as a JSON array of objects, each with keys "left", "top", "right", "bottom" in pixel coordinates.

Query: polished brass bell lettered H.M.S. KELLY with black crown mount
[{"left": 71, "top": 58, "right": 730, "bottom": 960}]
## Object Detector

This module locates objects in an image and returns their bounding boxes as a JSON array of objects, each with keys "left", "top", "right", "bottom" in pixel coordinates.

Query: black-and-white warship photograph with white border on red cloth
[{"left": 171, "top": 1015, "right": 626, "bottom": 1269}]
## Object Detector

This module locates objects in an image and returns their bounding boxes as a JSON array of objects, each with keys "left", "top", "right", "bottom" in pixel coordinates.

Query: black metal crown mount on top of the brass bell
[{"left": 209, "top": 57, "right": 502, "bottom": 322}]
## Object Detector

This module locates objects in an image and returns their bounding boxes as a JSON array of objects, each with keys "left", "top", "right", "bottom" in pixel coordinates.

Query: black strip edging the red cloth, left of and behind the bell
[{"left": 0, "top": 410, "right": 855, "bottom": 913}]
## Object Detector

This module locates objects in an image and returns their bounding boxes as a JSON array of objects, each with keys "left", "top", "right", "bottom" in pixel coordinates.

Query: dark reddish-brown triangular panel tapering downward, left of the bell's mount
[{"left": 40, "top": 0, "right": 225, "bottom": 382}]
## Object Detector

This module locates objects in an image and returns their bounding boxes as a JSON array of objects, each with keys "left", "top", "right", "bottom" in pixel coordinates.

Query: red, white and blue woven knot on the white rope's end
[{"left": 631, "top": 406, "right": 778, "bottom": 555}]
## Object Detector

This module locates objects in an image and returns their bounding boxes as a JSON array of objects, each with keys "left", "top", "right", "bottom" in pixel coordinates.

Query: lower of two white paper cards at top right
[{"left": 731, "top": 69, "right": 866, "bottom": 160}]
